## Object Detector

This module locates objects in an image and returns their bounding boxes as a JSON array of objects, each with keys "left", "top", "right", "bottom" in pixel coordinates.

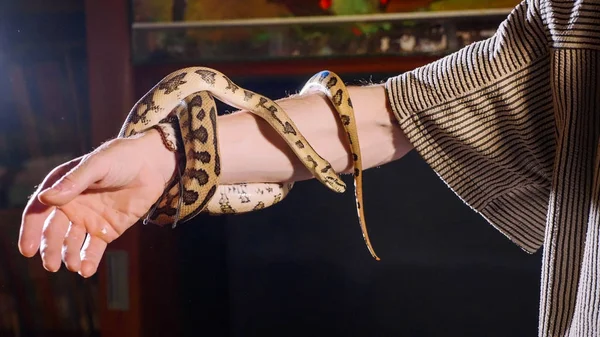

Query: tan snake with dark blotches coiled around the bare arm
[{"left": 117, "top": 66, "right": 380, "bottom": 261}]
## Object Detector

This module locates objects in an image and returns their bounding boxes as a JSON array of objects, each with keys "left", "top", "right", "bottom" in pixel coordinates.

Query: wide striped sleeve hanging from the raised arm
[{"left": 386, "top": 0, "right": 555, "bottom": 253}]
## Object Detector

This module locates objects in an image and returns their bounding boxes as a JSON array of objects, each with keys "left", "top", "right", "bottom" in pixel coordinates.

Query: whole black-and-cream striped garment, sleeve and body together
[{"left": 386, "top": 0, "right": 600, "bottom": 337}]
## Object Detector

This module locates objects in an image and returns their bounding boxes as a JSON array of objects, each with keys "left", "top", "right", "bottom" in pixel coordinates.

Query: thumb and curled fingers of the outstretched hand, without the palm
[{"left": 18, "top": 140, "right": 128, "bottom": 277}]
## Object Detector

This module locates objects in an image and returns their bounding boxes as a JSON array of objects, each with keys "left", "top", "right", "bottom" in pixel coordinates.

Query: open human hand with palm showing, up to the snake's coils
[{"left": 19, "top": 130, "right": 175, "bottom": 277}]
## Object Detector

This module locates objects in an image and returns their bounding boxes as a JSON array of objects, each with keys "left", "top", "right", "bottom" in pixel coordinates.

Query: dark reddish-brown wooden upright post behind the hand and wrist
[{"left": 85, "top": 0, "right": 177, "bottom": 337}]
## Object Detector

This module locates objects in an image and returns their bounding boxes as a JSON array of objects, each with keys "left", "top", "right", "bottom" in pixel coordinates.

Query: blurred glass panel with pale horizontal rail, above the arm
[{"left": 132, "top": 0, "right": 518, "bottom": 64}]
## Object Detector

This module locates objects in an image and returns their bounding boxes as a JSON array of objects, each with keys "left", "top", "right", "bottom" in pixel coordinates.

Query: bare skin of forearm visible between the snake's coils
[{"left": 149, "top": 85, "right": 412, "bottom": 184}]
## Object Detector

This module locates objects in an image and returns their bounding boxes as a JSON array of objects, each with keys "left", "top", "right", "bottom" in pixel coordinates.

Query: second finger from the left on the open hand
[{"left": 40, "top": 208, "right": 69, "bottom": 272}]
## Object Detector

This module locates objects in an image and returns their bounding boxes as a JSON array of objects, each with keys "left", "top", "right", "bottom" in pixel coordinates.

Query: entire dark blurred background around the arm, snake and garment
[{"left": 0, "top": 0, "right": 541, "bottom": 337}]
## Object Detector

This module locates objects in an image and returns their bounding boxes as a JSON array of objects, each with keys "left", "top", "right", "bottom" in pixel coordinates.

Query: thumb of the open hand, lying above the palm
[{"left": 38, "top": 152, "right": 108, "bottom": 206}]
